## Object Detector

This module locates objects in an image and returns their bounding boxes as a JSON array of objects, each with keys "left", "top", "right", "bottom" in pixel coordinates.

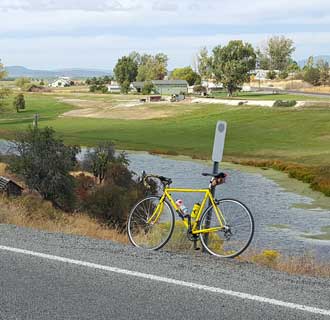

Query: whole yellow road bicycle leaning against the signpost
[{"left": 127, "top": 173, "right": 254, "bottom": 258}]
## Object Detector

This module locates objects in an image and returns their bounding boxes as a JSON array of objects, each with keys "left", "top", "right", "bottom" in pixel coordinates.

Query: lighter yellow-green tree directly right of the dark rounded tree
[{"left": 134, "top": 53, "right": 168, "bottom": 81}]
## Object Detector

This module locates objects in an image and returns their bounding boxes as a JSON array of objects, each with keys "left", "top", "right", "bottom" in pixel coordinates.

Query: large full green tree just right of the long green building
[{"left": 213, "top": 40, "right": 256, "bottom": 96}]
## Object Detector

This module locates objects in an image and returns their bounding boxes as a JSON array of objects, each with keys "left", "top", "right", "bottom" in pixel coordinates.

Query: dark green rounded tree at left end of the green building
[{"left": 114, "top": 56, "right": 138, "bottom": 93}]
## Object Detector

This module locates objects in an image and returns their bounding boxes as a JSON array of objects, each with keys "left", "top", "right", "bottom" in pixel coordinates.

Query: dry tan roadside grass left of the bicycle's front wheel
[{"left": 0, "top": 194, "right": 128, "bottom": 243}]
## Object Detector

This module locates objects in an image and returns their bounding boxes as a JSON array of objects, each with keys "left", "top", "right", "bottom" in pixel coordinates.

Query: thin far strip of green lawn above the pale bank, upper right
[{"left": 212, "top": 92, "right": 330, "bottom": 101}]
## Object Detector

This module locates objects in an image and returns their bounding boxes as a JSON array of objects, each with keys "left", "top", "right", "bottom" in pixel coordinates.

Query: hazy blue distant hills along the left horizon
[{"left": 5, "top": 66, "right": 112, "bottom": 79}]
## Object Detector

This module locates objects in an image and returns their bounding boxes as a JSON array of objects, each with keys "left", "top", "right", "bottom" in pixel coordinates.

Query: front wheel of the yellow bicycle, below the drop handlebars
[{"left": 127, "top": 196, "right": 175, "bottom": 250}]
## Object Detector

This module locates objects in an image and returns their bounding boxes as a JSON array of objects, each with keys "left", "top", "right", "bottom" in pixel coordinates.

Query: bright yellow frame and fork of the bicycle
[{"left": 147, "top": 188, "right": 226, "bottom": 235}]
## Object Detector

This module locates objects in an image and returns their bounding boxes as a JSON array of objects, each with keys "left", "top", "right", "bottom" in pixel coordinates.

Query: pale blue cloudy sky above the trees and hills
[{"left": 0, "top": 0, "right": 330, "bottom": 70}]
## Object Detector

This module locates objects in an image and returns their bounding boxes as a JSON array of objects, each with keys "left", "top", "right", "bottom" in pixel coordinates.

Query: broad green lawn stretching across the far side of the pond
[{"left": 0, "top": 94, "right": 330, "bottom": 165}]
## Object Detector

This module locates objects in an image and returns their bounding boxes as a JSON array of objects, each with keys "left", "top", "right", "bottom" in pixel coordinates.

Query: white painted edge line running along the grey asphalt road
[{"left": 0, "top": 246, "right": 330, "bottom": 316}]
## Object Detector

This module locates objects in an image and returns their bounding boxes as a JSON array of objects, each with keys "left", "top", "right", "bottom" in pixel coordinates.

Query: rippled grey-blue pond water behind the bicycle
[{"left": 0, "top": 141, "right": 330, "bottom": 261}]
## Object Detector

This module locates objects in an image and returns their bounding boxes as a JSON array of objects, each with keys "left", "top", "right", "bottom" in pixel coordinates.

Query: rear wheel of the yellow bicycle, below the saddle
[{"left": 199, "top": 199, "right": 254, "bottom": 258}]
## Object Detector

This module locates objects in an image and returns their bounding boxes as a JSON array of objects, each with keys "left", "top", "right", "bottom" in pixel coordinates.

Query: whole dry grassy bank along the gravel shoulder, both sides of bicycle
[{"left": 0, "top": 194, "right": 330, "bottom": 277}]
